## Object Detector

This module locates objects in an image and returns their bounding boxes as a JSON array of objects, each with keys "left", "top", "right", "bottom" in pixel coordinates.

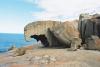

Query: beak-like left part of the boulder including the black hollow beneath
[{"left": 24, "top": 20, "right": 61, "bottom": 47}]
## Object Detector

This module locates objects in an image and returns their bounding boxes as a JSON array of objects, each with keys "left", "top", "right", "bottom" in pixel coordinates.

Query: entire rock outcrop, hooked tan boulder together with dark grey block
[{"left": 24, "top": 14, "right": 100, "bottom": 50}]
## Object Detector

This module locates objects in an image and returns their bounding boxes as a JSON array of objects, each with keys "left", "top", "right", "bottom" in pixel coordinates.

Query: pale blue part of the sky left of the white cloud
[{"left": 0, "top": 0, "right": 41, "bottom": 33}]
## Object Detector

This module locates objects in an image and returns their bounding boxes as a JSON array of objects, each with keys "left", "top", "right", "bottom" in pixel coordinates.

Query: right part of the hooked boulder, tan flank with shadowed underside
[{"left": 48, "top": 21, "right": 81, "bottom": 50}]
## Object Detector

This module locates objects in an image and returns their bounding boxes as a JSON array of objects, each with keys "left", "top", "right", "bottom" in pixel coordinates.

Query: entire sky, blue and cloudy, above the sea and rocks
[{"left": 0, "top": 0, "right": 100, "bottom": 33}]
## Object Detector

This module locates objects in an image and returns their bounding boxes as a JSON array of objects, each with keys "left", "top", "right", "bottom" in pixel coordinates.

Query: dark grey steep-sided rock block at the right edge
[{"left": 79, "top": 14, "right": 100, "bottom": 49}]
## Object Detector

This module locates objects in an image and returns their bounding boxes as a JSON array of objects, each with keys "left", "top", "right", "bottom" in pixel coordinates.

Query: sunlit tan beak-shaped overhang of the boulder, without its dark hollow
[{"left": 24, "top": 20, "right": 60, "bottom": 41}]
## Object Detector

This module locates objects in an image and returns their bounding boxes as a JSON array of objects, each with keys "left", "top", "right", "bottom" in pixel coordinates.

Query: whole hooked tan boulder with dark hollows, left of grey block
[{"left": 24, "top": 20, "right": 81, "bottom": 50}]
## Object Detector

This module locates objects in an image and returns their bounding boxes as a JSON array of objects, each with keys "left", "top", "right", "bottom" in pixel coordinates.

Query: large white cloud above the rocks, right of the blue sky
[{"left": 33, "top": 0, "right": 100, "bottom": 20}]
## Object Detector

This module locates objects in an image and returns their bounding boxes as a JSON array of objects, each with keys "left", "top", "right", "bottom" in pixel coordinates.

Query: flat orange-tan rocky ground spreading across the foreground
[{"left": 0, "top": 44, "right": 100, "bottom": 67}]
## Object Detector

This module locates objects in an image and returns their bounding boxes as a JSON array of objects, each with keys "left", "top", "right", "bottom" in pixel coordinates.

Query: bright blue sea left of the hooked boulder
[{"left": 0, "top": 33, "right": 36, "bottom": 53}]
